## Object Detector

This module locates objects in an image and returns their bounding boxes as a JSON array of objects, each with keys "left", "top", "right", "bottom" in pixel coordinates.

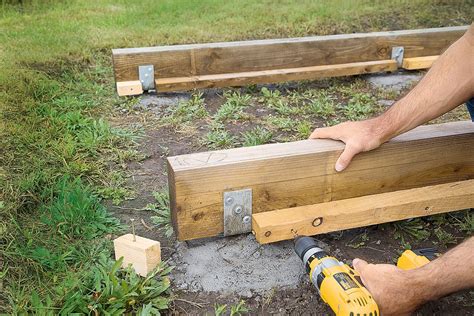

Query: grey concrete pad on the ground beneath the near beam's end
[{"left": 170, "top": 234, "right": 328, "bottom": 297}]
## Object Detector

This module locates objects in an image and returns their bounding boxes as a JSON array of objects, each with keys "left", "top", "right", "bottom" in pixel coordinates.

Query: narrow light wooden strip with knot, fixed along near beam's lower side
[{"left": 252, "top": 180, "right": 474, "bottom": 244}]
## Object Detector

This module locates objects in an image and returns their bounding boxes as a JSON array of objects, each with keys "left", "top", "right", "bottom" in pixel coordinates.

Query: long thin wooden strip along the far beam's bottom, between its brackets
[{"left": 155, "top": 59, "right": 397, "bottom": 92}]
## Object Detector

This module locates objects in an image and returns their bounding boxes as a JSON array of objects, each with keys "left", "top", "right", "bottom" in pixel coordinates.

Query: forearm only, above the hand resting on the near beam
[{"left": 374, "top": 23, "right": 474, "bottom": 143}]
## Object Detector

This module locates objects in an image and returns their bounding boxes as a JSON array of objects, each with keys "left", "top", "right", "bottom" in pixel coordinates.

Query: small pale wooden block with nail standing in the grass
[{"left": 114, "top": 234, "right": 161, "bottom": 276}]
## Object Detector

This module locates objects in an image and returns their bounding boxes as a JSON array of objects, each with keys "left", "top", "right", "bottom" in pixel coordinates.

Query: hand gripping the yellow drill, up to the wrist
[{"left": 352, "top": 259, "right": 424, "bottom": 316}]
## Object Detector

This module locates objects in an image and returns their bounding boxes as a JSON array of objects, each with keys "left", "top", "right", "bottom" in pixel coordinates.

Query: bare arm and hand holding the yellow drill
[{"left": 353, "top": 237, "right": 474, "bottom": 315}]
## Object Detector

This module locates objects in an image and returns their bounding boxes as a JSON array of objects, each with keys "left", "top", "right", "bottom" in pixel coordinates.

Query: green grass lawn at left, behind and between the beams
[{"left": 0, "top": 0, "right": 474, "bottom": 314}]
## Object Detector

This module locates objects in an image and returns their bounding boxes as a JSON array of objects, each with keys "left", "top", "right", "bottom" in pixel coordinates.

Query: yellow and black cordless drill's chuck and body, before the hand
[{"left": 295, "top": 236, "right": 379, "bottom": 316}]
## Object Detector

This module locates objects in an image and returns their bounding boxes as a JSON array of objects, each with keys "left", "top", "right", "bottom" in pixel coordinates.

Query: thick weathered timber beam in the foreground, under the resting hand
[{"left": 168, "top": 121, "right": 474, "bottom": 240}]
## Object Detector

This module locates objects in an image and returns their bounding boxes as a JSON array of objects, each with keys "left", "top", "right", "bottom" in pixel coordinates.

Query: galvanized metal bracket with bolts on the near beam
[{"left": 223, "top": 189, "right": 252, "bottom": 236}]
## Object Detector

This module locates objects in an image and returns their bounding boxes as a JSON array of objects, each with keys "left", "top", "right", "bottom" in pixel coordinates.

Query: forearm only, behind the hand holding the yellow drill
[{"left": 407, "top": 237, "right": 474, "bottom": 302}]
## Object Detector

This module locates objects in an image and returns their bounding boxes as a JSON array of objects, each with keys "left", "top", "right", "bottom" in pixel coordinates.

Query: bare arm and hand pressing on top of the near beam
[{"left": 310, "top": 23, "right": 474, "bottom": 171}]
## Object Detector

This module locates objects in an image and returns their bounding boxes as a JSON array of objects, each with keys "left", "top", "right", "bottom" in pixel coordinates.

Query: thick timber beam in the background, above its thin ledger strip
[{"left": 112, "top": 26, "right": 468, "bottom": 82}]
